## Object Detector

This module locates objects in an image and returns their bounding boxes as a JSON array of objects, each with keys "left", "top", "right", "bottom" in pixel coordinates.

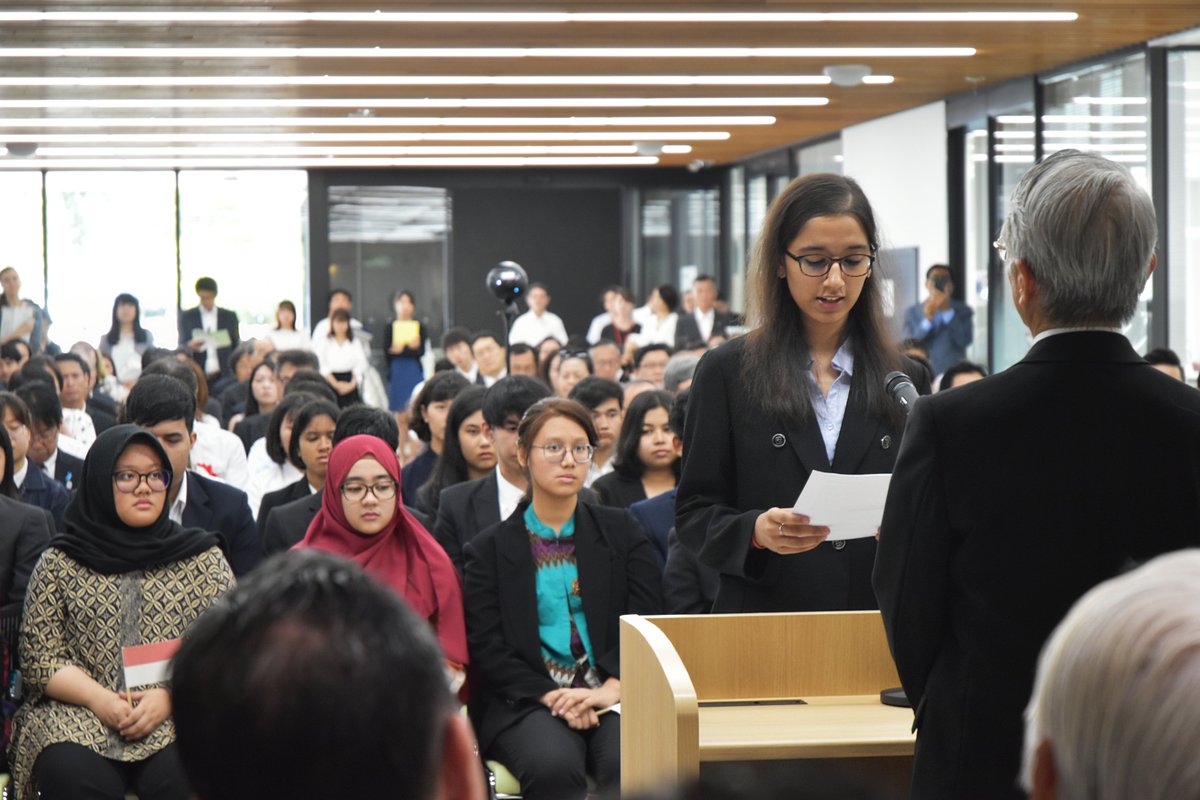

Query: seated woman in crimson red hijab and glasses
[{"left": 295, "top": 435, "right": 467, "bottom": 688}]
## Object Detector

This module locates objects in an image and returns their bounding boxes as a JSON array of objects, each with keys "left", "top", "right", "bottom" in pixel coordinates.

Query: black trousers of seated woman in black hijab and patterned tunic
[{"left": 32, "top": 742, "right": 192, "bottom": 800}]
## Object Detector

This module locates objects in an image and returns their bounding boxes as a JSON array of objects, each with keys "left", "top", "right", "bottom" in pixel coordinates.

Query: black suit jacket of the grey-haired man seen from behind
[{"left": 874, "top": 332, "right": 1200, "bottom": 798}]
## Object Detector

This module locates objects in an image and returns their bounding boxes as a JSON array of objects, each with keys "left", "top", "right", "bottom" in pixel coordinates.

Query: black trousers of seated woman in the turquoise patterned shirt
[{"left": 487, "top": 708, "right": 620, "bottom": 800}]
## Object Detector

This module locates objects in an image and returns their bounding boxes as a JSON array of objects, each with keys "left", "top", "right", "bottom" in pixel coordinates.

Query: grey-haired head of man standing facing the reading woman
[{"left": 1000, "top": 150, "right": 1158, "bottom": 327}]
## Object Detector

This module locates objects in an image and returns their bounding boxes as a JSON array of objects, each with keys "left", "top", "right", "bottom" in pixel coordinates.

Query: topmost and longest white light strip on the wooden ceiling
[{"left": 0, "top": 10, "right": 1079, "bottom": 24}]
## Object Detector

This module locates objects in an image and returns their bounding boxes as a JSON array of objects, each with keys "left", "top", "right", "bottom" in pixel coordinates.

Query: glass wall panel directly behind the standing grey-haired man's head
[{"left": 1042, "top": 54, "right": 1153, "bottom": 353}]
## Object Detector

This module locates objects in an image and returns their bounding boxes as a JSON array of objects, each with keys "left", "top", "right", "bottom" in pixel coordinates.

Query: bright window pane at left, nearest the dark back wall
[{"left": 179, "top": 170, "right": 309, "bottom": 338}]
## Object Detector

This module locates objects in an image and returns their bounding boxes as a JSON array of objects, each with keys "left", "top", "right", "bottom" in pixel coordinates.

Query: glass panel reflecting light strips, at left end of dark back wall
[{"left": 328, "top": 186, "right": 450, "bottom": 351}]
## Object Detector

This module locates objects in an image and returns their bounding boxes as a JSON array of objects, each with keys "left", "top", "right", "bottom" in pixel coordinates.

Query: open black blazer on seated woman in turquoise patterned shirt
[{"left": 463, "top": 503, "right": 662, "bottom": 752}]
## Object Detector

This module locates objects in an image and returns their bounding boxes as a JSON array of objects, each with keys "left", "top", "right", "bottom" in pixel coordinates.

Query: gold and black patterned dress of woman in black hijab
[{"left": 10, "top": 547, "right": 234, "bottom": 800}]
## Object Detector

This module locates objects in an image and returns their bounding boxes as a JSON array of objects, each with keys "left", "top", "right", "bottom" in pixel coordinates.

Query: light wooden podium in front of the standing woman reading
[{"left": 620, "top": 612, "right": 916, "bottom": 793}]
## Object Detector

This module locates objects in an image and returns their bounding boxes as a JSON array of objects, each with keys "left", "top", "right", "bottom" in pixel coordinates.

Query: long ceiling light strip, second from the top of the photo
[{"left": 0, "top": 47, "right": 976, "bottom": 61}]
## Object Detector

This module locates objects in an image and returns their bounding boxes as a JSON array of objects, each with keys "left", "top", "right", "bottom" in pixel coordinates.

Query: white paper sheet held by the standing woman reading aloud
[{"left": 792, "top": 470, "right": 892, "bottom": 542}]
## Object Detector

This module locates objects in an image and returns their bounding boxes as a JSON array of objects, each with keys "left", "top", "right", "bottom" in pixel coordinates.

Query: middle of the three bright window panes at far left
[{"left": 46, "top": 172, "right": 179, "bottom": 348}]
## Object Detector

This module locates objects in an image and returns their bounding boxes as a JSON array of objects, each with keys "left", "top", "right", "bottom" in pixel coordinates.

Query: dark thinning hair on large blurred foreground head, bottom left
[{"left": 172, "top": 549, "right": 455, "bottom": 800}]
